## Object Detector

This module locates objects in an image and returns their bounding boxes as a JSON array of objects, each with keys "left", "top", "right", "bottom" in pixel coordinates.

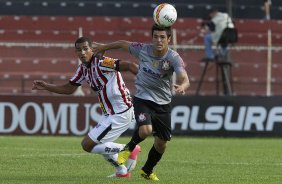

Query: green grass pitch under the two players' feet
[{"left": 0, "top": 136, "right": 282, "bottom": 184}]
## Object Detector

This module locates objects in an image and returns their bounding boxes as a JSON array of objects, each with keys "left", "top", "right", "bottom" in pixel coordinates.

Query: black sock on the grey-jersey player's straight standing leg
[{"left": 142, "top": 145, "right": 163, "bottom": 174}]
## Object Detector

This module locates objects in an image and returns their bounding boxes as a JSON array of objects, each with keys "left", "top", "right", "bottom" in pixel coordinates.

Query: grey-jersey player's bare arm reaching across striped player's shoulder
[{"left": 92, "top": 40, "right": 131, "bottom": 54}]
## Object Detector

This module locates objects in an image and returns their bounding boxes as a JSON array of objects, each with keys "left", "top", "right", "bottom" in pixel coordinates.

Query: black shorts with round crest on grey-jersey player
[{"left": 133, "top": 97, "right": 171, "bottom": 141}]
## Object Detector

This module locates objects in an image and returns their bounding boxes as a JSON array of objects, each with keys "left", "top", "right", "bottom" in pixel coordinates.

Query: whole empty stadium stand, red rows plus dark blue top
[{"left": 0, "top": 0, "right": 282, "bottom": 95}]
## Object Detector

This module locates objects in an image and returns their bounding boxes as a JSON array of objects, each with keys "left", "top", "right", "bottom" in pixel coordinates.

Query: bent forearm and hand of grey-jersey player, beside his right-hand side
[{"left": 174, "top": 72, "right": 190, "bottom": 95}]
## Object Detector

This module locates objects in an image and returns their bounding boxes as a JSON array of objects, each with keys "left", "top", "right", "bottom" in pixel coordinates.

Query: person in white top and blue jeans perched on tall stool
[{"left": 202, "top": 9, "right": 234, "bottom": 62}]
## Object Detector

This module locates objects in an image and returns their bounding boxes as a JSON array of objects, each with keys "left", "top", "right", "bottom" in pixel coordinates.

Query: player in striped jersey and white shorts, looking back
[{"left": 32, "top": 37, "right": 140, "bottom": 177}]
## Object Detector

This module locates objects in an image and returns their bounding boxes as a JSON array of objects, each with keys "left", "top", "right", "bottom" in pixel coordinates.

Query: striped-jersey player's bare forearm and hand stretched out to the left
[{"left": 32, "top": 80, "right": 77, "bottom": 95}]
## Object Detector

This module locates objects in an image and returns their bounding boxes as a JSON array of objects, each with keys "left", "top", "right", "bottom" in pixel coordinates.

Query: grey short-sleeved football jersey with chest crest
[{"left": 129, "top": 42, "right": 185, "bottom": 105}]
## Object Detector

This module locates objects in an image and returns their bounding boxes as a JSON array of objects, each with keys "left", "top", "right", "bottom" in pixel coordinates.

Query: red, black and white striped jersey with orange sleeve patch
[{"left": 69, "top": 56, "right": 132, "bottom": 115}]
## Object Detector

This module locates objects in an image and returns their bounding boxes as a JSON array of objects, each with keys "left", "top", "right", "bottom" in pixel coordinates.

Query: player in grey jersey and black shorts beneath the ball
[{"left": 93, "top": 24, "right": 190, "bottom": 181}]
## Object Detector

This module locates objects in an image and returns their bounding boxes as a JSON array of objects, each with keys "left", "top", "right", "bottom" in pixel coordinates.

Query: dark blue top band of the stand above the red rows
[{"left": 0, "top": 0, "right": 282, "bottom": 19}]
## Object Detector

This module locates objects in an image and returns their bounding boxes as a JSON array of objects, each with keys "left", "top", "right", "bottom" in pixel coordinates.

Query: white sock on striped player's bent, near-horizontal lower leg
[{"left": 91, "top": 142, "right": 125, "bottom": 155}]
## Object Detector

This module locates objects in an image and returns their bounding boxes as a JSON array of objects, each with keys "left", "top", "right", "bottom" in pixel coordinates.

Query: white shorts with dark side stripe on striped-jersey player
[{"left": 88, "top": 107, "right": 135, "bottom": 143}]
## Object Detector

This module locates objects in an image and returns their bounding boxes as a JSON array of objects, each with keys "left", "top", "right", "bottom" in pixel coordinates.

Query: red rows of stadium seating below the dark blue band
[{"left": 0, "top": 16, "right": 282, "bottom": 95}]
